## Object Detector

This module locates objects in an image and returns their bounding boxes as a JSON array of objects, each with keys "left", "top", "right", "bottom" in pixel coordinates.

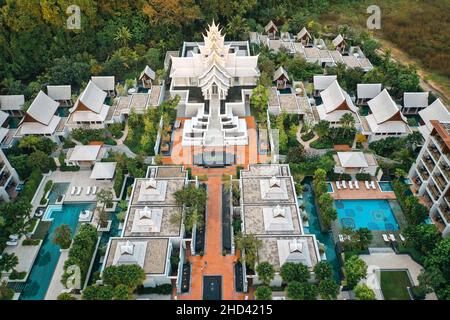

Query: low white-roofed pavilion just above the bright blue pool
[{"left": 333, "top": 151, "right": 378, "bottom": 177}]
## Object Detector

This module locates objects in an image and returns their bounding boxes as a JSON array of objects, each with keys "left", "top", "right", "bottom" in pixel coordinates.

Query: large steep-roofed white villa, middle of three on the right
[{"left": 361, "top": 89, "right": 412, "bottom": 142}]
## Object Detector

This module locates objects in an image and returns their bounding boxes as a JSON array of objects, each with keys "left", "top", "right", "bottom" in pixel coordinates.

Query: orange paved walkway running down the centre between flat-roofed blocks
[{"left": 178, "top": 176, "right": 245, "bottom": 300}]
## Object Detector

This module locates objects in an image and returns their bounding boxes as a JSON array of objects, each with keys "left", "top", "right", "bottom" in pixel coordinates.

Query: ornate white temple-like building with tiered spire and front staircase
[{"left": 170, "top": 22, "right": 260, "bottom": 146}]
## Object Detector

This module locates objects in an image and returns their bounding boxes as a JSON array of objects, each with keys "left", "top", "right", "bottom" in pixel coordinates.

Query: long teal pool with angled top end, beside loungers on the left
[{"left": 20, "top": 203, "right": 94, "bottom": 300}]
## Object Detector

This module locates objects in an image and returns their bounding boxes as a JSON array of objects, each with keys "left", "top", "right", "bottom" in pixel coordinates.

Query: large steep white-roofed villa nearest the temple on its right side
[{"left": 316, "top": 80, "right": 358, "bottom": 126}]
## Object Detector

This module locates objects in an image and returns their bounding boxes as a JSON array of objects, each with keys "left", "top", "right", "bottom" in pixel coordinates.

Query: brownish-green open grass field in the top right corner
[{"left": 319, "top": 0, "right": 450, "bottom": 100}]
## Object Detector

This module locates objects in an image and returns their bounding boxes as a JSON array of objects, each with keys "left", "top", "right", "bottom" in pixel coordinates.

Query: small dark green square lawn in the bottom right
[{"left": 380, "top": 271, "right": 412, "bottom": 300}]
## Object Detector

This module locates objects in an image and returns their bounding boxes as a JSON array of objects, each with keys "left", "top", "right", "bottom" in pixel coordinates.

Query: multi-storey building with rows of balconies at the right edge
[{"left": 409, "top": 120, "right": 450, "bottom": 237}]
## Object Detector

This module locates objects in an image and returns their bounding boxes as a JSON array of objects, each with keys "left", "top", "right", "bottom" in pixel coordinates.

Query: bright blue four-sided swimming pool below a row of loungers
[{"left": 334, "top": 200, "right": 399, "bottom": 231}]
